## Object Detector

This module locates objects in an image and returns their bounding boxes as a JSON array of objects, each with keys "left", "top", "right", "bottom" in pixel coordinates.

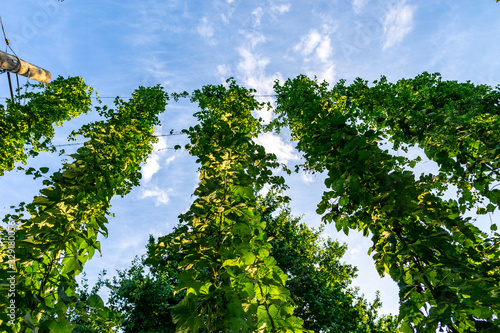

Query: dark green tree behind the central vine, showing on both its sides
[{"left": 74, "top": 193, "right": 397, "bottom": 333}]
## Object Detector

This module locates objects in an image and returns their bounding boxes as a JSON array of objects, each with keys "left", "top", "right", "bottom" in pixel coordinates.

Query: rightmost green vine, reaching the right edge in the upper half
[{"left": 342, "top": 73, "right": 500, "bottom": 214}]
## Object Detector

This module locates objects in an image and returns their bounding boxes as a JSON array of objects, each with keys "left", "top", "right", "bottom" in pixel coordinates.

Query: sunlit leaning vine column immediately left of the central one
[{"left": 0, "top": 86, "right": 167, "bottom": 333}]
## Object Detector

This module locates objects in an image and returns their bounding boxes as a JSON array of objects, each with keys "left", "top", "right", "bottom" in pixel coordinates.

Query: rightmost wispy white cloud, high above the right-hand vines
[{"left": 383, "top": 0, "right": 416, "bottom": 49}]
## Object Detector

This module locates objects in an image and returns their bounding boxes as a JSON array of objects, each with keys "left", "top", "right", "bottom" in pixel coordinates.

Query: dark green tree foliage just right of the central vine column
[{"left": 260, "top": 192, "right": 398, "bottom": 333}]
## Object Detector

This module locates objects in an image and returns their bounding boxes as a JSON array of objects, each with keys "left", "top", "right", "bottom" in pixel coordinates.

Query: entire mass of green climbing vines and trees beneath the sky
[{"left": 0, "top": 73, "right": 500, "bottom": 333}]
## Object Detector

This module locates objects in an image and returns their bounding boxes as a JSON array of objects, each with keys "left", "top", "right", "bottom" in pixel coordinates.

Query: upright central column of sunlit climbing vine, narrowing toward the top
[{"left": 148, "top": 81, "right": 303, "bottom": 332}]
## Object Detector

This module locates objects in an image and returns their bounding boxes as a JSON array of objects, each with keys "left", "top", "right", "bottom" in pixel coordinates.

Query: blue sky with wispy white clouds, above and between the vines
[{"left": 0, "top": 0, "right": 500, "bottom": 313}]
